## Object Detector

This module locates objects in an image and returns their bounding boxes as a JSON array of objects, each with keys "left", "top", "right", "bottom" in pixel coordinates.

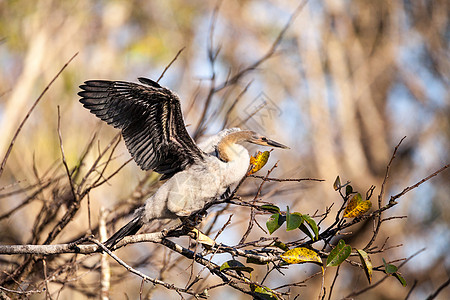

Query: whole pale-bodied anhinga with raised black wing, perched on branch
[{"left": 78, "top": 78, "right": 288, "bottom": 248}]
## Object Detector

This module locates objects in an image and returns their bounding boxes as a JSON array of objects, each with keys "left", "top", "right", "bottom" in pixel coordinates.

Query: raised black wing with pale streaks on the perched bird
[{"left": 78, "top": 78, "right": 203, "bottom": 178}]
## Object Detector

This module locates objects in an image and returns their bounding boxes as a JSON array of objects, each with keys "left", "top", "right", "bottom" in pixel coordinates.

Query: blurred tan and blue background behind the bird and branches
[{"left": 0, "top": 0, "right": 450, "bottom": 299}]
